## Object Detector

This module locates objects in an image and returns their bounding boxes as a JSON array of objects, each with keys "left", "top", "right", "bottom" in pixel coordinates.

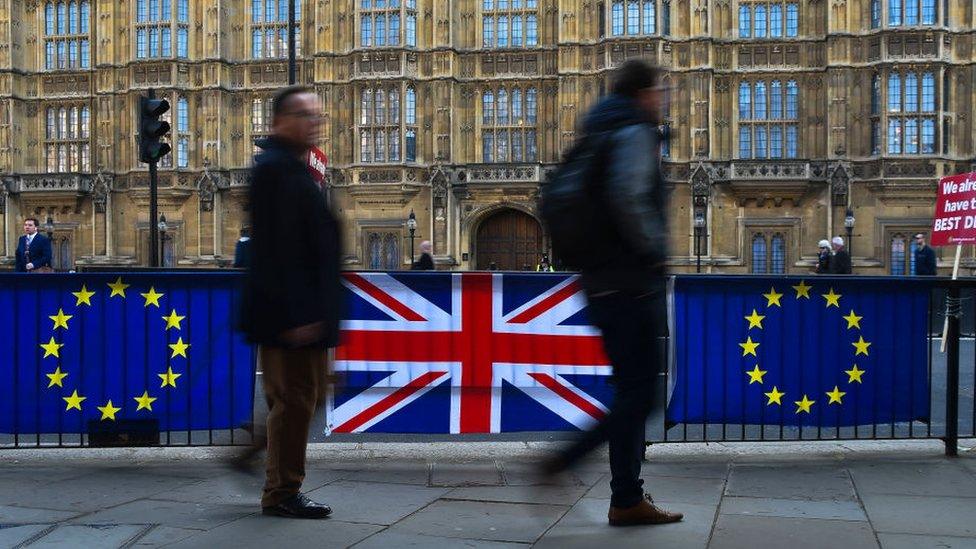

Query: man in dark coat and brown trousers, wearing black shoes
[{"left": 241, "top": 86, "right": 340, "bottom": 518}]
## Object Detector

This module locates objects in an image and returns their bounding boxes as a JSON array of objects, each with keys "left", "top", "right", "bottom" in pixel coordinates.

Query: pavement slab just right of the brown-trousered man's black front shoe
[{"left": 308, "top": 480, "right": 450, "bottom": 525}]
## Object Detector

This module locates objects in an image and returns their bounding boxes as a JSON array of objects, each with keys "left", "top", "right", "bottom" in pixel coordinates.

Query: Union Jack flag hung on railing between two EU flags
[{"left": 327, "top": 273, "right": 612, "bottom": 433}]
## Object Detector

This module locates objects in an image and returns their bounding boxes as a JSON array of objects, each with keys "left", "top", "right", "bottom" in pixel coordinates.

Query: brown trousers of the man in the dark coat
[{"left": 259, "top": 347, "right": 328, "bottom": 507}]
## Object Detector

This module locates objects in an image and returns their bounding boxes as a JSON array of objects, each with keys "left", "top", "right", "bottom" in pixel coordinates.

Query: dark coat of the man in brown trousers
[{"left": 240, "top": 138, "right": 341, "bottom": 347}]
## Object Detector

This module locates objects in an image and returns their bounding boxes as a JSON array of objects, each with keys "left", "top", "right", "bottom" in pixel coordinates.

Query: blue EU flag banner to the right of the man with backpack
[{"left": 668, "top": 276, "right": 930, "bottom": 427}]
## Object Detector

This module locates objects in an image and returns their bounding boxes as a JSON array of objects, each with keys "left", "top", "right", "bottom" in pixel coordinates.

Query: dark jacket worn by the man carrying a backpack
[{"left": 582, "top": 95, "right": 668, "bottom": 293}]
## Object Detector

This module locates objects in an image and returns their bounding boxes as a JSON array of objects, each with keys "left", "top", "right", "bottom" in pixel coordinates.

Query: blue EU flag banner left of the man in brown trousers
[{"left": 0, "top": 272, "right": 255, "bottom": 434}]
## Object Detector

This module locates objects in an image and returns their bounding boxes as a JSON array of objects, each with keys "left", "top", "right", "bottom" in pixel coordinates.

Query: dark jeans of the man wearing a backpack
[{"left": 562, "top": 291, "right": 667, "bottom": 507}]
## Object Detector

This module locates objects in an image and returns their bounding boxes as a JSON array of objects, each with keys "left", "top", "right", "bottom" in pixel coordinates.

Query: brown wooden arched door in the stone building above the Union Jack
[{"left": 475, "top": 209, "right": 543, "bottom": 271}]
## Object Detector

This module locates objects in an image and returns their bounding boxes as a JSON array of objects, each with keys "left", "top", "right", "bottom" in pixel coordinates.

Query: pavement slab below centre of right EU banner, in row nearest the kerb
[{"left": 725, "top": 464, "right": 855, "bottom": 501}]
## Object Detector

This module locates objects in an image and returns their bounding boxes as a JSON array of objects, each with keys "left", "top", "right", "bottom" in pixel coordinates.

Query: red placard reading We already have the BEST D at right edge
[{"left": 931, "top": 172, "right": 976, "bottom": 246}]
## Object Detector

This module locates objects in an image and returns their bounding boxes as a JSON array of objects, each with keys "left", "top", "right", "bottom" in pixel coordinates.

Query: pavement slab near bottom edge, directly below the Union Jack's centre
[{"left": 391, "top": 500, "right": 569, "bottom": 543}]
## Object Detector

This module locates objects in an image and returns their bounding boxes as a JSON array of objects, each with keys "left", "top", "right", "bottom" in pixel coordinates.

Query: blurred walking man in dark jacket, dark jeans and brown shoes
[{"left": 544, "top": 60, "right": 682, "bottom": 526}]
